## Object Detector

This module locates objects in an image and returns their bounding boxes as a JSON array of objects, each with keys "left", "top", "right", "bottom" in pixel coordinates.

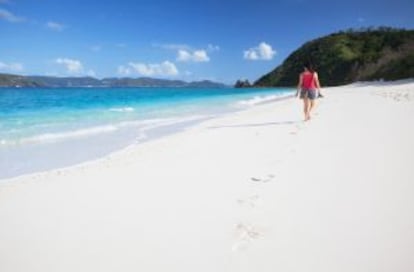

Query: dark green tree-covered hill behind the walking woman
[{"left": 253, "top": 27, "right": 414, "bottom": 87}]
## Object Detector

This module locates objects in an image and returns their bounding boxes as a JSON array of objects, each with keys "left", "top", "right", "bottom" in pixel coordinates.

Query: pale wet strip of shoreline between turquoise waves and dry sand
[{"left": 0, "top": 90, "right": 291, "bottom": 183}]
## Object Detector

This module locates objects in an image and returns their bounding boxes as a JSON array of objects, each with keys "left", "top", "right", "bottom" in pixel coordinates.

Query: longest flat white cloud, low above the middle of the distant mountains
[{"left": 118, "top": 61, "right": 179, "bottom": 76}]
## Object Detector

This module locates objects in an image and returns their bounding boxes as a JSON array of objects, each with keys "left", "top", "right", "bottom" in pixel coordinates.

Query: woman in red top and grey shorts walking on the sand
[{"left": 296, "top": 62, "right": 321, "bottom": 121}]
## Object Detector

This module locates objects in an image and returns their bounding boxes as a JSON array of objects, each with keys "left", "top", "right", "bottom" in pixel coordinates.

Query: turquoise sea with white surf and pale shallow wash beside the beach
[{"left": 0, "top": 88, "right": 292, "bottom": 179}]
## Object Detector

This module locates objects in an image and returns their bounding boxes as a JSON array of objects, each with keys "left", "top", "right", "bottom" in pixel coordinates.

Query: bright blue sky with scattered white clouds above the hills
[{"left": 0, "top": 0, "right": 414, "bottom": 84}]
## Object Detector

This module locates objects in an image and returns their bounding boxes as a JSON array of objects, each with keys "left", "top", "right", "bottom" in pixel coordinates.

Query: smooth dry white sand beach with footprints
[{"left": 0, "top": 81, "right": 414, "bottom": 272}]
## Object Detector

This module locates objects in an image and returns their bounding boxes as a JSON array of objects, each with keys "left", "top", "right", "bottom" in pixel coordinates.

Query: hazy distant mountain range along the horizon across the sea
[{"left": 0, "top": 74, "right": 228, "bottom": 88}]
